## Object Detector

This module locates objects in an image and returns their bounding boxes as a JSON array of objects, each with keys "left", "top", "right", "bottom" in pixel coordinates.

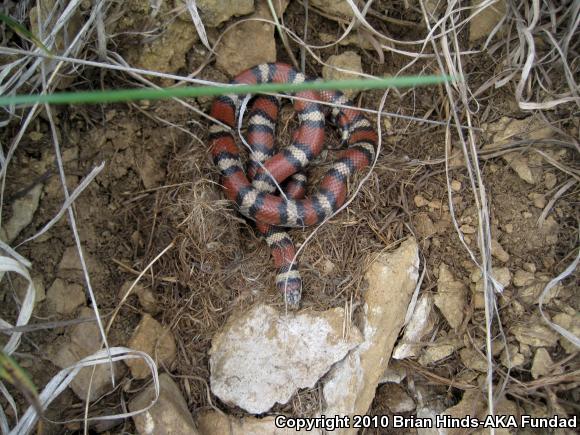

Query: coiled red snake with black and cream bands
[{"left": 209, "top": 63, "right": 377, "bottom": 307}]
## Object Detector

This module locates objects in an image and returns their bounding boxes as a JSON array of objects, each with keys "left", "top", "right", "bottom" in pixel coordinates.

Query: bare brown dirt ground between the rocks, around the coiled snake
[{"left": 0, "top": 2, "right": 580, "bottom": 433}]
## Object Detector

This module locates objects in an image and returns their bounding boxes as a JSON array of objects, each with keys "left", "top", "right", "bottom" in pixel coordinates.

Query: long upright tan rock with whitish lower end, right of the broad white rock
[{"left": 322, "top": 239, "right": 419, "bottom": 434}]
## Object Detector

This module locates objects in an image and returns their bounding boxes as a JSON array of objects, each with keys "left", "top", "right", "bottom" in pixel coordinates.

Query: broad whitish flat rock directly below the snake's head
[{"left": 210, "top": 305, "right": 362, "bottom": 414}]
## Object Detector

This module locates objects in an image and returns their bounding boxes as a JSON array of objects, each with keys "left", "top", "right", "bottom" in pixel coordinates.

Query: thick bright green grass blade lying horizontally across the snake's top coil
[{"left": 0, "top": 75, "right": 452, "bottom": 106}]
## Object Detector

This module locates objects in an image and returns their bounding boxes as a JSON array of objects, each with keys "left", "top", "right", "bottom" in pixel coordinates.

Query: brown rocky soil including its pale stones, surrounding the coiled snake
[{"left": 0, "top": 0, "right": 580, "bottom": 434}]
